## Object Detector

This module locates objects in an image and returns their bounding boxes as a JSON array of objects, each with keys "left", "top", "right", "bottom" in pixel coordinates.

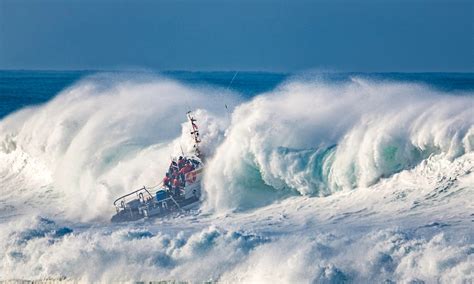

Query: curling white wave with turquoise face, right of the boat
[{"left": 205, "top": 79, "right": 474, "bottom": 211}]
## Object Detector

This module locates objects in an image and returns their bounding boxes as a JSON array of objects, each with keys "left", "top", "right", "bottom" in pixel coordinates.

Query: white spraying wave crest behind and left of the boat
[{"left": 0, "top": 74, "right": 238, "bottom": 220}]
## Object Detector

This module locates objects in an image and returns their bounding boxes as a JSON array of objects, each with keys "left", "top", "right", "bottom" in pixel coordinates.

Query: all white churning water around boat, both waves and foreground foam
[{"left": 0, "top": 73, "right": 474, "bottom": 283}]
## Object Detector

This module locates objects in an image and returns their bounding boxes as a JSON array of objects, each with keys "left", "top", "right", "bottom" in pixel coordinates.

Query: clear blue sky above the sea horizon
[{"left": 0, "top": 0, "right": 474, "bottom": 72}]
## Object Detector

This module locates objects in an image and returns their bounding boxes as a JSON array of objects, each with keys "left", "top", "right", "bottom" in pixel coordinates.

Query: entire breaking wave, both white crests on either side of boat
[{"left": 0, "top": 72, "right": 474, "bottom": 220}]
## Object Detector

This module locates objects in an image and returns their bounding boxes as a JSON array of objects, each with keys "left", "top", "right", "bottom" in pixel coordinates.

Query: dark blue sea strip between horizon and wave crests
[{"left": 0, "top": 70, "right": 474, "bottom": 118}]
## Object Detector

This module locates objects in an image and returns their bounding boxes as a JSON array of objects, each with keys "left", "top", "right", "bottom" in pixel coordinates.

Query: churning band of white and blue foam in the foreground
[{"left": 0, "top": 215, "right": 473, "bottom": 283}]
